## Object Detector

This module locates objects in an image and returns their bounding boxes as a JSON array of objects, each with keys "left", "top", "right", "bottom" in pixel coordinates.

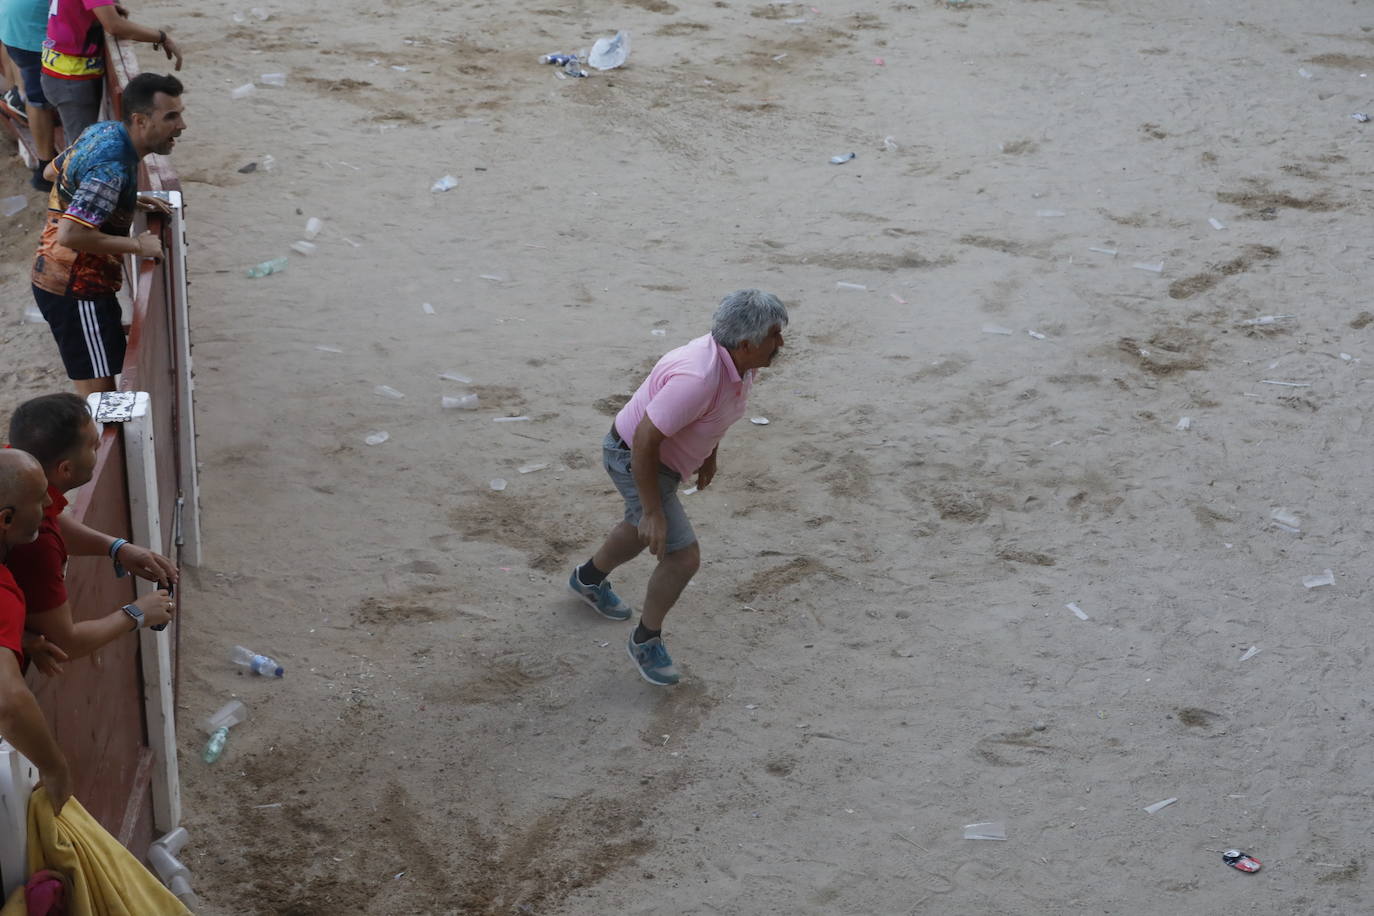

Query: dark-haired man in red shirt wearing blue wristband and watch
[{"left": 7, "top": 394, "right": 177, "bottom": 661}]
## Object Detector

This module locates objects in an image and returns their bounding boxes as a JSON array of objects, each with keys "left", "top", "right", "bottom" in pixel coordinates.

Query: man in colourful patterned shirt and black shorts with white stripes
[{"left": 32, "top": 73, "right": 185, "bottom": 396}]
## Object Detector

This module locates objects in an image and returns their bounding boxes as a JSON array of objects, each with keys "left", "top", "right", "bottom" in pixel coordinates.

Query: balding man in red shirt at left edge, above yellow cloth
[{"left": 0, "top": 449, "right": 71, "bottom": 813}]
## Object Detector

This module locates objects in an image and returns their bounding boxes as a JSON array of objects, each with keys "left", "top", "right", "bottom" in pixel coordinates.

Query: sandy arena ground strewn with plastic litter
[{"left": 8, "top": 0, "right": 1374, "bottom": 916}]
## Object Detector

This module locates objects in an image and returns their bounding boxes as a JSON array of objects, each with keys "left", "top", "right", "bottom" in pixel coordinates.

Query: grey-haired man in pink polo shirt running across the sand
[{"left": 567, "top": 290, "right": 787, "bottom": 687}]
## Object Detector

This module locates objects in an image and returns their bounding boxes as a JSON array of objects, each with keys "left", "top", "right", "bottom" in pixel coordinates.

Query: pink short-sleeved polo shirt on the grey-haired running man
[{"left": 616, "top": 334, "right": 754, "bottom": 477}]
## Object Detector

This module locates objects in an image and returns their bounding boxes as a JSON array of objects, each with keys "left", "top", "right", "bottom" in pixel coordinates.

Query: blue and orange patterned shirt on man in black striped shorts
[{"left": 33, "top": 121, "right": 139, "bottom": 299}]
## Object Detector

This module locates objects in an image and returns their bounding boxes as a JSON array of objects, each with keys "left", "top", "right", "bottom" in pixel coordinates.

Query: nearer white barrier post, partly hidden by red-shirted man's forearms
[{"left": 124, "top": 391, "right": 181, "bottom": 834}]
